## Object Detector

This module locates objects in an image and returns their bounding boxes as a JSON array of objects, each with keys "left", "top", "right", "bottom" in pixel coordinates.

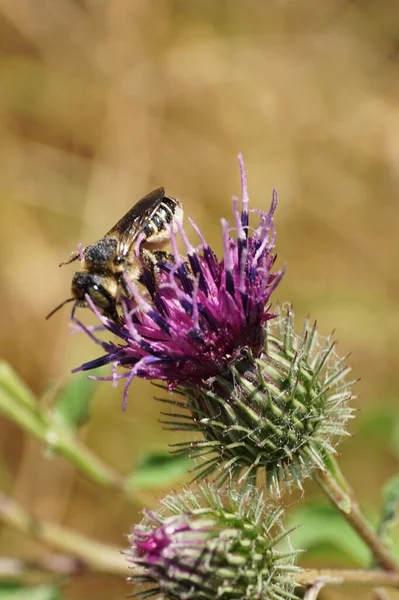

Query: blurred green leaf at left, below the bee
[{"left": 53, "top": 373, "right": 97, "bottom": 429}]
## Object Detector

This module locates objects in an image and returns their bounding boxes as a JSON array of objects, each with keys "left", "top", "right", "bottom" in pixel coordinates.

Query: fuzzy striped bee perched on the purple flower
[{"left": 46, "top": 187, "right": 183, "bottom": 321}]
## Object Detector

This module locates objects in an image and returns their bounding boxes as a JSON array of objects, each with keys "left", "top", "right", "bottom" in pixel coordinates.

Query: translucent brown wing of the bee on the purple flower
[{"left": 104, "top": 187, "right": 165, "bottom": 256}]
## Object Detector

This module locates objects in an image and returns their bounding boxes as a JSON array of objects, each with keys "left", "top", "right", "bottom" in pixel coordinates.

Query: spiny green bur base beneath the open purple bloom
[{"left": 163, "top": 309, "right": 354, "bottom": 493}]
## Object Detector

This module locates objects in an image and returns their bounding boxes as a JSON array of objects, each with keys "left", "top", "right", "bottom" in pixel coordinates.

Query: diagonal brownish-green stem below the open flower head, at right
[{"left": 313, "top": 457, "right": 399, "bottom": 572}]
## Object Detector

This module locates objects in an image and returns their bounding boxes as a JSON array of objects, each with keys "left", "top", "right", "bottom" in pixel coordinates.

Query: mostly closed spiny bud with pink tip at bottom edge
[{"left": 127, "top": 485, "right": 299, "bottom": 600}]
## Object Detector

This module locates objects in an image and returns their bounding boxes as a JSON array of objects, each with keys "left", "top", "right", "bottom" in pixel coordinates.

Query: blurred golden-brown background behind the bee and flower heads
[{"left": 0, "top": 0, "right": 399, "bottom": 600}]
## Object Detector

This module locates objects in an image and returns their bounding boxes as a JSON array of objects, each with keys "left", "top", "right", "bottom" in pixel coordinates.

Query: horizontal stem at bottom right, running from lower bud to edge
[{"left": 295, "top": 569, "right": 399, "bottom": 588}]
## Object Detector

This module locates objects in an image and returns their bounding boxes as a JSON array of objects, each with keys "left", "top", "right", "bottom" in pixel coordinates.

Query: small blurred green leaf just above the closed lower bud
[{"left": 127, "top": 452, "right": 192, "bottom": 489}]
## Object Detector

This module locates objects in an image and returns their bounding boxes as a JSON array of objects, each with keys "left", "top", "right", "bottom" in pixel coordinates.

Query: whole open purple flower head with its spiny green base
[{"left": 72, "top": 159, "right": 352, "bottom": 493}]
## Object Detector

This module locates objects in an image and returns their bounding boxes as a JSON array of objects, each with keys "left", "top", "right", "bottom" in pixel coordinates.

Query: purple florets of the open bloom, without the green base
[{"left": 76, "top": 156, "right": 283, "bottom": 406}]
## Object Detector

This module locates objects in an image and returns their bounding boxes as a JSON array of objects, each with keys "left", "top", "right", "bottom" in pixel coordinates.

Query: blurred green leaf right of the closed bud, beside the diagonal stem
[{"left": 287, "top": 503, "right": 370, "bottom": 567}]
